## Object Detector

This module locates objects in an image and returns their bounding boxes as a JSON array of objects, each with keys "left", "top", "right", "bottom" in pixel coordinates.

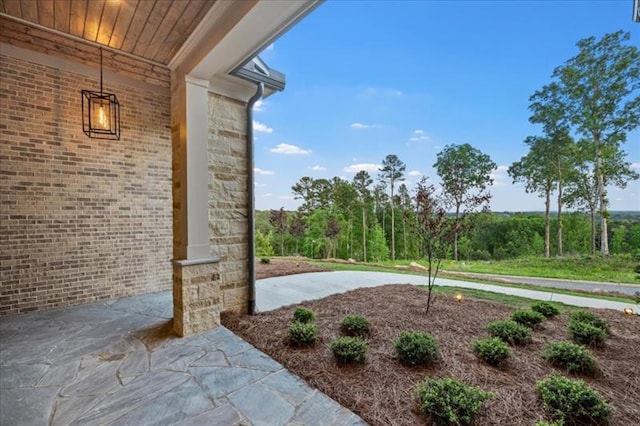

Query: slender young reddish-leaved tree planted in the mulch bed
[{"left": 415, "top": 178, "right": 449, "bottom": 315}]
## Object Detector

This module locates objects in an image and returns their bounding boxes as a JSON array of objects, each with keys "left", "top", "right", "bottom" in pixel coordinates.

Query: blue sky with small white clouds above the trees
[{"left": 254, "top": 0, "right": 640, "bottom": 211}]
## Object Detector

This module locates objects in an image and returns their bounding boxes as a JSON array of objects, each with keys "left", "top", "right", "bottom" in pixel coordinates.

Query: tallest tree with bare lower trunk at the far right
[{"left": 553, "top": 31, "right": 640, "bottom": 256}]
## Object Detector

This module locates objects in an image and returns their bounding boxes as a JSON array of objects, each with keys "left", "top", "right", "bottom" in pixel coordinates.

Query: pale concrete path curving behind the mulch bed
[{"left": 256, "top": 271, "right": 639, "bottom": 313}]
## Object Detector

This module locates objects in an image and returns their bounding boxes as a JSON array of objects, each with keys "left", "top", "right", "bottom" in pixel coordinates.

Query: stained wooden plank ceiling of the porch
[{"left": 0, "top": 0, "right": 216, "bottom": 65}]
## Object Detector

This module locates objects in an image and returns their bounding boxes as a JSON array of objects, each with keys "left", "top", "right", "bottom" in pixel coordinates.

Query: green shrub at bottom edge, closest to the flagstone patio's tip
[{"left": 414, "top": 378, "right": 494, "bottom": 425}]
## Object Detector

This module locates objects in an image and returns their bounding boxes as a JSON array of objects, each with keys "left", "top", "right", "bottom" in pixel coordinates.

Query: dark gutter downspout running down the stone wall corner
[{"left": 247, "top": 83, "right": 264, "bottom": 315}]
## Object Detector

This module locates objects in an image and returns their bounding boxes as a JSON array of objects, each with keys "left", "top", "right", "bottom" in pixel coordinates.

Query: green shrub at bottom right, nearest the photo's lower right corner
[{"left": 536, "top": 374, "right": 612, "bottom": 425}]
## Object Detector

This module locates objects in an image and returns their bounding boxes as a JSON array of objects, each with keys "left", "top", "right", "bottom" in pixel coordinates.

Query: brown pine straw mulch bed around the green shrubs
[{"left": 223, "top": 285, "right": 640, "bottom": 425}]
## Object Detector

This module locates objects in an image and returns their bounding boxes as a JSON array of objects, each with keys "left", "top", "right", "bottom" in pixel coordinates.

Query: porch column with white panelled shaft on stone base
[{"left": 171, "top": 75, "right": 222, "bottom": 336}]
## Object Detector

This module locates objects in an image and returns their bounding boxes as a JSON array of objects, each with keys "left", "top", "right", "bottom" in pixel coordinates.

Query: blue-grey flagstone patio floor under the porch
[{"left": 0, "top": 292, "right": 365, "bottom": 426}]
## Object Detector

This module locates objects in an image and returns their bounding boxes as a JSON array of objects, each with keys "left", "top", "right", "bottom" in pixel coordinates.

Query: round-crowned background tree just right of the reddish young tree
[{"left": 433, "top": 143, "right": 496, "bottom": 260}]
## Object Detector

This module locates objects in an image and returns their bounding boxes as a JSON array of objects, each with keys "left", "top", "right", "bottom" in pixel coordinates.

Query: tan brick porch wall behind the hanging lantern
[{"left": 0, "top": 51, "right": 172, "bottom": 315}]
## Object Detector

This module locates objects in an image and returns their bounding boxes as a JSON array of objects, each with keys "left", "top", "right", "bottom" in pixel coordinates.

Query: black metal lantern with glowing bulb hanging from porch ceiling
[{"left": 82, "top": 48, "right": 120, "bottom": 140}]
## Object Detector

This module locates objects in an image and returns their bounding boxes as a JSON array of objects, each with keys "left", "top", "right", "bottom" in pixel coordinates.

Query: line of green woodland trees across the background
[{"left": 256, "top": 31, "right": 640, "bottom": 261}]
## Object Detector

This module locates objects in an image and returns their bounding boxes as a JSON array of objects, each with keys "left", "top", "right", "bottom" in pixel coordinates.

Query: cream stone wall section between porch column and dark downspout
[{"left": 209, "top": 93, "right": 249, "bottom": 312}]
